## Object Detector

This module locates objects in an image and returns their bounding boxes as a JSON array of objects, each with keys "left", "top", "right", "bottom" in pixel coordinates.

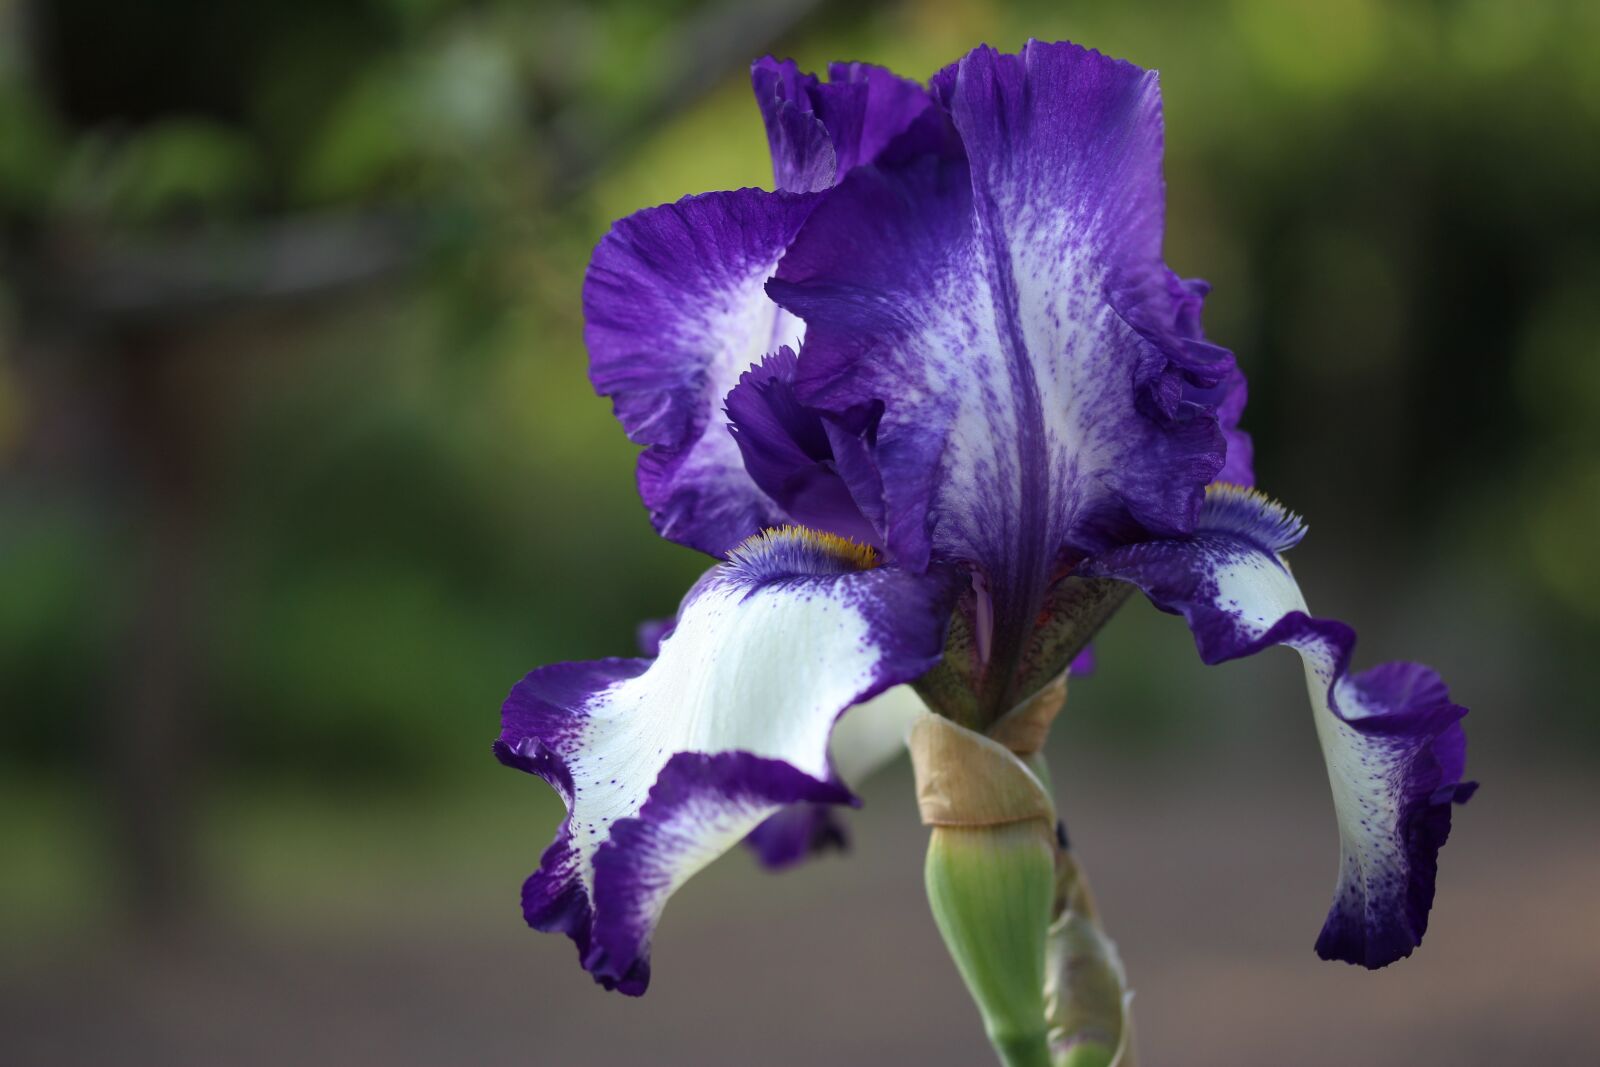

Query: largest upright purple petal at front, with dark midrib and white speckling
[{"left": 768, "top": 42, "right": 1232, "bottom": 713}]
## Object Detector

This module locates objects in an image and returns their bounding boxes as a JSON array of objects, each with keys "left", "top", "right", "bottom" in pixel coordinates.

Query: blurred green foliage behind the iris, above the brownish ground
[{"left": 0, "top": 0, "right": 1600, "bottom": 793}]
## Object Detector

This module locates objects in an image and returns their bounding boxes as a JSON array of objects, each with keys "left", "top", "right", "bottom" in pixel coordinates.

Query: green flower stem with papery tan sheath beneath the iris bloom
[{"left": 909, "top": 700, "right": 1133, "bottom": 1067}]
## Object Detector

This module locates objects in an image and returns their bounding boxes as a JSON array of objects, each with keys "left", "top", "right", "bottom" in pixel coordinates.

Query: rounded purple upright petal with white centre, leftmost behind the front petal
[{"left": 584, "top": 189, "right": 811, "bottom": 557}]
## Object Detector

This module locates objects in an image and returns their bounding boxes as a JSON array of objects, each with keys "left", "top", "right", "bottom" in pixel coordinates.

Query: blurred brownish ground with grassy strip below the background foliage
[{"left": 0, "top": 742, "right": 1600, "bottom": 1067}]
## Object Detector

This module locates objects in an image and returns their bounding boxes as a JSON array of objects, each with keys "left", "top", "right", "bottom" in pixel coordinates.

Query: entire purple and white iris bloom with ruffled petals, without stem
[{"left": 496, "top": 42, "right": 1472, "bottom": 993}]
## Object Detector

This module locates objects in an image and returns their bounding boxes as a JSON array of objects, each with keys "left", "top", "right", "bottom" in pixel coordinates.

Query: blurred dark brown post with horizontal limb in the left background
[{"left": 13, "top": 216, "right": 418, "bottom": 934}]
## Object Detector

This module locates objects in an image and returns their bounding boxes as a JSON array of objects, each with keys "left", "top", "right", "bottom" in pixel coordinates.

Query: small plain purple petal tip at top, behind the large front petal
[{"left": 750, "top": 56, "right": 930, "bottom": 192}]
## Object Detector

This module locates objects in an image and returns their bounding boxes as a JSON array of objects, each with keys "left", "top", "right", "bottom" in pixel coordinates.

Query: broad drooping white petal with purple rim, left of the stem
[{"left": 494, "top": 528, "right": 950, "bottom": 995}]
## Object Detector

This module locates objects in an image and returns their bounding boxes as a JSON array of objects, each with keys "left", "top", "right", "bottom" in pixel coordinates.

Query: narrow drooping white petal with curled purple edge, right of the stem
[{"left": 1080, "top": 485, "right": 1475, "bottom": 968}]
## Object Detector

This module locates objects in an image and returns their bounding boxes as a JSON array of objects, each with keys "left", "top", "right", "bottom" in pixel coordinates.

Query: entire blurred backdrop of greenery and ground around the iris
[{"left": 0, "top": 0, "right": 1600, "bottom": 1067}]
